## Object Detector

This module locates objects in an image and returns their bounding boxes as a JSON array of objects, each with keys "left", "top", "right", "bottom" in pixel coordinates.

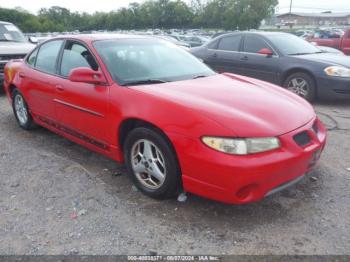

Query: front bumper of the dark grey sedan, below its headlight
[{"left": 317, "top": 76, "right": 350, "bottom": 99}]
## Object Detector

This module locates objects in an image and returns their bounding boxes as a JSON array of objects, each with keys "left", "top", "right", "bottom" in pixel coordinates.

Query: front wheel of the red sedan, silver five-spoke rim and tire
[{"left": 124, "top": 127, "right": 181, "bottom": 199}]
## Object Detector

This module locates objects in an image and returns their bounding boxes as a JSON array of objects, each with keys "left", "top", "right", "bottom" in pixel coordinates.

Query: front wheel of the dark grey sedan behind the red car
[{"left": 283, "top": 72, "right": 316, "bottom": 102}]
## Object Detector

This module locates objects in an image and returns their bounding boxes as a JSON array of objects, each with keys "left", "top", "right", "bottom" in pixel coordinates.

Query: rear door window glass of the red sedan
[{"left": 35, "top": 40, "right": 63, "bottom": 74}]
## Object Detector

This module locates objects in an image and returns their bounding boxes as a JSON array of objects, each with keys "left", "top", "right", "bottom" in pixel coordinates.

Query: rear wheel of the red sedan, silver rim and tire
[{"left": 12, "top": 89, "right": 36, "bottom": 130}]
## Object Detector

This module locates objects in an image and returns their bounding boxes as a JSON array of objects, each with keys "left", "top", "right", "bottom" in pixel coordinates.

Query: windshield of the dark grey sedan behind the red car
[{"left": 268, "top": 34, "right": 322, "bottom": 55}]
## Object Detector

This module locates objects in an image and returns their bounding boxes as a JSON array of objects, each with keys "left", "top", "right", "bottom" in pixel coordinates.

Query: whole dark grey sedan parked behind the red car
[{"left": 191, "top": 32, "right": 350, "bottom": 101}]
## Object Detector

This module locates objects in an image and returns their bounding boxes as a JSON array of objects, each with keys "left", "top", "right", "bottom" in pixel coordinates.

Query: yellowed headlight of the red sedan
[{"left": 202, "top": 136, "right": 281, "bottom": 155}]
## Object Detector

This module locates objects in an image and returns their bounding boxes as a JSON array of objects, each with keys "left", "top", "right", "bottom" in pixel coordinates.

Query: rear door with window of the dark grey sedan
[{"left": 207, "top": 34, "right": 242, "bottom": 74}]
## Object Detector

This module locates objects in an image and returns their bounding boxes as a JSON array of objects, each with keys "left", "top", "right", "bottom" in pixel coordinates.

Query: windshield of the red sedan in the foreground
[{"left": 94, "top": 39, "right": 215, "bottom": 85}]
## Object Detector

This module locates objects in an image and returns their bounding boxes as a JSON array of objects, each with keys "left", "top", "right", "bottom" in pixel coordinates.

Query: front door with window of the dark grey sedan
[{"left": 240, "top": 34, "right": 279, "bottom": 84}]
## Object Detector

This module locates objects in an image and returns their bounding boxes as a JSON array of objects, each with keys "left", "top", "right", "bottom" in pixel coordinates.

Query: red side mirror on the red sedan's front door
[{"left": 68, "top": 67, "right": 107, "bottom": 85}]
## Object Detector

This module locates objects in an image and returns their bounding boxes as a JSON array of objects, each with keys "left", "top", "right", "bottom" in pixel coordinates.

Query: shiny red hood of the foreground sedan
[{"left": 131, "top": 74, "right": 315, "bottom": 137}]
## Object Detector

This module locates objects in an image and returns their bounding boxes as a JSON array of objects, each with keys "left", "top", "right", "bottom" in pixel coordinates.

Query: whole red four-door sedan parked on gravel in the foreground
[{"left": 4, "top": 35, "right": 326, "bottom": 204}]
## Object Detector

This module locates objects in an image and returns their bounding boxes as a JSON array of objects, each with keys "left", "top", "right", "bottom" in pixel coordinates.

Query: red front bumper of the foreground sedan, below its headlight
[{"left": 170, "top": 117, "right": 326, "bottom": 204}]
